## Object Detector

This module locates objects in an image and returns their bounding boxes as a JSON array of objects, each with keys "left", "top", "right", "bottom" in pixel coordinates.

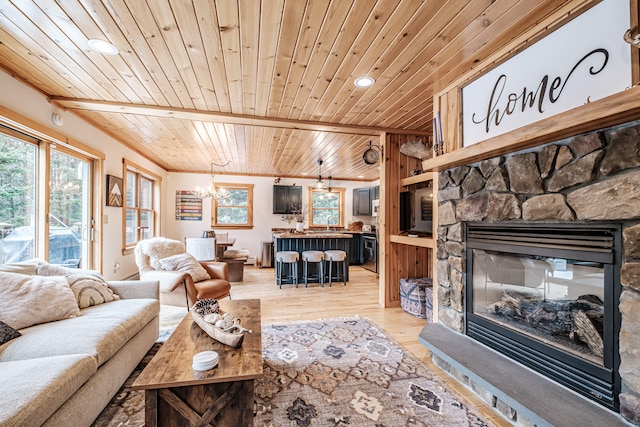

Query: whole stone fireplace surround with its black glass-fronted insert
[{"left": 436, "top": 121, "right": 640, "bottom": 424}]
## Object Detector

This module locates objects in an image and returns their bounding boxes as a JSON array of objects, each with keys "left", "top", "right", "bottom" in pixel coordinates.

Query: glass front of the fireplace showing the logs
[{"left": 473, "top": 249, "right": 605, "bottom": 365}]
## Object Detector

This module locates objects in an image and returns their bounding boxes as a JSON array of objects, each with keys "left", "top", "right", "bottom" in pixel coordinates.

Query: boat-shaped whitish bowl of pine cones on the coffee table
[{"left": 190, "top": 298, "right": 251, "bottom": 348}]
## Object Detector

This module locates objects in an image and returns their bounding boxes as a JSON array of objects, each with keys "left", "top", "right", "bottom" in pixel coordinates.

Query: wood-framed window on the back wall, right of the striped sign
[{"left": 211, "top": 184, "right": 253, "bottom": 228}]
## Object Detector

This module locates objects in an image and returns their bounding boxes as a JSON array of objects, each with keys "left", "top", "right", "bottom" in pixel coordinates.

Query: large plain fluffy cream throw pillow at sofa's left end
[{"left": 0, "top": 272, "right": 80, "bottom": 329}]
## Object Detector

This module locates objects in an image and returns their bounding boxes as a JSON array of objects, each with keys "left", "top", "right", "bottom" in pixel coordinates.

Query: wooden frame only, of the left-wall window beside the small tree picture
[{"left": 122, "top": 159, "right": 162, "bottom": 254}]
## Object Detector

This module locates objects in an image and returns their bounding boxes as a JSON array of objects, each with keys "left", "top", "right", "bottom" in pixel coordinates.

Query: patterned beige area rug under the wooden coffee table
[{"left": 94, "top": 318, "right": 493, "bottom": 427}]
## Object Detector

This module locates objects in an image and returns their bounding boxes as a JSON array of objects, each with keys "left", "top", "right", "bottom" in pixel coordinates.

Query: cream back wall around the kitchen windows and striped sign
[{"left": 163, "top": 172, "right": 377, "bottom": 258}]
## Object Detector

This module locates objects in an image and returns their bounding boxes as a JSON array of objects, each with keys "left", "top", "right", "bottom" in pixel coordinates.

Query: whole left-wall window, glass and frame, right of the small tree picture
[{"left": 123, "top": 161, "right": 160, "bottom": 249}]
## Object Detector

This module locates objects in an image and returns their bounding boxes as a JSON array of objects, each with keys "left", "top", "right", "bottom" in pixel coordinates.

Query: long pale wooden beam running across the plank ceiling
[{"left": 49, "top": 96, "right": 433, "bottom": 136}]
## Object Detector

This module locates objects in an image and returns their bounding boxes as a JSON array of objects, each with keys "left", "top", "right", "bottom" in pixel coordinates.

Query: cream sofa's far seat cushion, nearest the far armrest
[{"left": 0, "top": 299, "right": 160, "bottom": 366}]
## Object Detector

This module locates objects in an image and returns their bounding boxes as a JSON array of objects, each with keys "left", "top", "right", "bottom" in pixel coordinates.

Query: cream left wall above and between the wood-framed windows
[{"left": 0, "top": 71, "right": 166, "bottom": 280}]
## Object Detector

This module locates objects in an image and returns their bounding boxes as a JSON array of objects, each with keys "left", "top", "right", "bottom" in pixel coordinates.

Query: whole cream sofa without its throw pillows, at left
[{"left": 0, "top": 266, "right": 160, "bottom": 427}]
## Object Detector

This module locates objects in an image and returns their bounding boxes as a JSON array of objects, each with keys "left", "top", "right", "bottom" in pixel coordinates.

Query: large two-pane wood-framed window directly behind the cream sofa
[{"left": 0, "top": 127, "right": 94, "bottom": 268}]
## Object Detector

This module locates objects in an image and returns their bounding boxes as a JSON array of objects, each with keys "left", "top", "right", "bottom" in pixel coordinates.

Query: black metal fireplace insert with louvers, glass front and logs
[{"left": 465, "top": 223, "right": 621, "bottom": 411}]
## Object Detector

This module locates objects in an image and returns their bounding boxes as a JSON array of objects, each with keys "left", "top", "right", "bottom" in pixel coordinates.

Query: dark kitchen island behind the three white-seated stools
[{"left": 273, "top": 231, "right": 353, "bottom": 283}]
